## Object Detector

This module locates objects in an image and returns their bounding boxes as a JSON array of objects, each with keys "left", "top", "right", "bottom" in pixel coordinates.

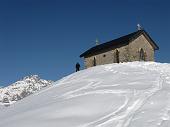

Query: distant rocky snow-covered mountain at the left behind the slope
[{"left": 0, "top": 75, "right": 53, "bottom": 106}]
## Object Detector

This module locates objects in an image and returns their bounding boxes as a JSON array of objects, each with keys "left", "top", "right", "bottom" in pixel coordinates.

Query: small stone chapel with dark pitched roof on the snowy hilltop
[{"left": 80, "top": 29, "right": 159, "bottom": 68}]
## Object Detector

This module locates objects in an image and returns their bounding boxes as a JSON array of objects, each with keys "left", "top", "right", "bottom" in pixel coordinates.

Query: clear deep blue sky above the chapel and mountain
[{"left": 0, "top": 0, "right": 170, "bottom": 86}]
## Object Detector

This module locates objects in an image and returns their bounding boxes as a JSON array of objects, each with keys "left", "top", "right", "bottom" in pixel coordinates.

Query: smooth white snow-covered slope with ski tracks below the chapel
[{"left": 0, "top": 62, "right": 170, "bottom": 127}]
